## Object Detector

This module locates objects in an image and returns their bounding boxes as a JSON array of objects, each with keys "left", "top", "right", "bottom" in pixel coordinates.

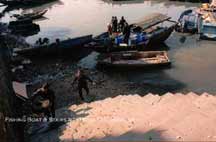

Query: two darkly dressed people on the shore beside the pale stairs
[{"left": 30, "top": 68, "right": 95, "bottom": 117}]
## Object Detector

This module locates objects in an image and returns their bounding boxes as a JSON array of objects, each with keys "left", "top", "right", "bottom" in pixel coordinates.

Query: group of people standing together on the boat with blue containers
[{"left": 107, "top": 16, "right": 131, "bottom": 43}]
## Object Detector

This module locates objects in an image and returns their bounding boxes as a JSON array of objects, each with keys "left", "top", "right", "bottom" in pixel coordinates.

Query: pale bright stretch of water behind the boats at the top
[{"left": 0, "top": 0, "right": 197, "bottom": 43}]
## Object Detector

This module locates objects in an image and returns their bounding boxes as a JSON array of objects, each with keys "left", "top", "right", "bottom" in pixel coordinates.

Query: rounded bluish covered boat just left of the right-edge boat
[{"left": 176, "top": 9, "right": 199, "bottom": 33}]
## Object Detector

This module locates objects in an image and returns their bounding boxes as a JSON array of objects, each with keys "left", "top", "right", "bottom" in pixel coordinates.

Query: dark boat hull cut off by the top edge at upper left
[{"left": 0, "top": 0, "right": 55, "bottom": 6}]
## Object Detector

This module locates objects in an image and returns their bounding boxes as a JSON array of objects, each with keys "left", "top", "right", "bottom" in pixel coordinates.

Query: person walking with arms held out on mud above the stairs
[{"left": 72, "top": 68, "right": 95, "bottom": 101}]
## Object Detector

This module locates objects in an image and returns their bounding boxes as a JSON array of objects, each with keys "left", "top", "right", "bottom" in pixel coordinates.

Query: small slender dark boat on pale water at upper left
[{"left": 13, "top": 10, "right": 48, "bottom": 20}]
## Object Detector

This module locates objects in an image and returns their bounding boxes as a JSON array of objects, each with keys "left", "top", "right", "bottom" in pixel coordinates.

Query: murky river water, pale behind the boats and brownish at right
[{"left": 1, "top": 0, "right": 216, "bottom": 93}]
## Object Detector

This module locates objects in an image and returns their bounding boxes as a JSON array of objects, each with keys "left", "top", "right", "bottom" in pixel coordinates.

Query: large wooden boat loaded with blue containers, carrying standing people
[{"left": 89, "top": 13, "right": 176, "bottom": 52}]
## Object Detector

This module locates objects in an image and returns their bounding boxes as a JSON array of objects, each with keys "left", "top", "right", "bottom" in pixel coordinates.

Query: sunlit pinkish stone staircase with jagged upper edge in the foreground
[{"left": 31, "top": 92, "right": 216, "bottom": 142}]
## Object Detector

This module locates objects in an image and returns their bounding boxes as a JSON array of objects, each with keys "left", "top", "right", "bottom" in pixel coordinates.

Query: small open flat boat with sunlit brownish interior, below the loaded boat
[{"left": 97, "top": 51, "right": 171, "bottom": 69}]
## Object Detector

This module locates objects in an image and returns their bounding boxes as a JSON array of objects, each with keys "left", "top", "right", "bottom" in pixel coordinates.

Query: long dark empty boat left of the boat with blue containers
[{"left": 16, "top": 35, "right": 92, "bottom": 58}]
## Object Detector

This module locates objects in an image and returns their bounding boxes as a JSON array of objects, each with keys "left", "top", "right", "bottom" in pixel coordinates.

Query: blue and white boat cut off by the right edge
[{"left": 198, "top": 14, "right": 216, "bottom": 40}]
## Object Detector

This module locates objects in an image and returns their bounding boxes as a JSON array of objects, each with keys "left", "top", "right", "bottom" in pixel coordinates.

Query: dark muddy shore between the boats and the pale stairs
[{"left": 14, "top": 51, "right": 190, "bottom": 108}]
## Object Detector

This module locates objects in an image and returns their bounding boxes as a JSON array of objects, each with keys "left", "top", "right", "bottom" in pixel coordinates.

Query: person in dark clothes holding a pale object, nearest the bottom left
[{"left": 30, "top": 83, "right": 55, "bottom": 117}]
